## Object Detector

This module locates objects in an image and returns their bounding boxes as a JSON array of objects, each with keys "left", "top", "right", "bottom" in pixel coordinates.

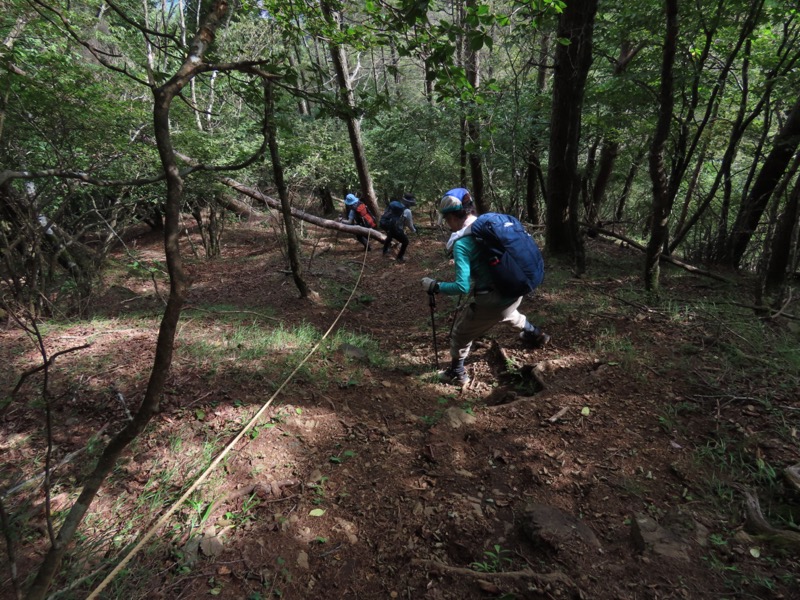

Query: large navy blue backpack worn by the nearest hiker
[{"left": 472, "top": 213, "right": 544, "bottom": 298}]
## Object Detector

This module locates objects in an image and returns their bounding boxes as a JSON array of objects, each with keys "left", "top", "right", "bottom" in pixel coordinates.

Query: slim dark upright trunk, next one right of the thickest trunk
[{"left": 644, "top": 0, "right": 678, "bottom": 292}]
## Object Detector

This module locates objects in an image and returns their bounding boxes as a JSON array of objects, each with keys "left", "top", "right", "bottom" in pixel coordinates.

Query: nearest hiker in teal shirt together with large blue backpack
[{"left": 422, "top": 194, "right": 550, "bottom": 386}]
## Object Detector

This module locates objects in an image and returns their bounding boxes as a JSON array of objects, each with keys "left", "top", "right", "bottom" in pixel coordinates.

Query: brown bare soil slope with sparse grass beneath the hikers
[{"left": 0, "top": 219, "right": 800, "bottom": 600}]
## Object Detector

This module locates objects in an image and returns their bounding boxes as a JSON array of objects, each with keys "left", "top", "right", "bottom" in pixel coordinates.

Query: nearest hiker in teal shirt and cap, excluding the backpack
[{"left": 422, "top": 195, "right": 550, "bottom": 386}]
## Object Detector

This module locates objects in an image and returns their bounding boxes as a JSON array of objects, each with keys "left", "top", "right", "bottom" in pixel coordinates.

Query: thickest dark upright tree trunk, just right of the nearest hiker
[{"left": 546, "top": 0, "right": 597, "bottom": 273}]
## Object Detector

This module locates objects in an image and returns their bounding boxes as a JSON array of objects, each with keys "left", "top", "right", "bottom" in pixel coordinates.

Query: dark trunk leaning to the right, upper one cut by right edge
[{"left": 724, "top": 96, "right": 800, "bottom": 268}]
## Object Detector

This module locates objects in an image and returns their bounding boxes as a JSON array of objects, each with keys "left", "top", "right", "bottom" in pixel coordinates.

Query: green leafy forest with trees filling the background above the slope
[{"left": 0, "top": 0, "right": 800, "bottom": 299}]
